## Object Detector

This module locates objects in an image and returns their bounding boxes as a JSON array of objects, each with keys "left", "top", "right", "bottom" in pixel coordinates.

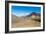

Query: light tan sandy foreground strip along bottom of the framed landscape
[{"left": 12, "top": 19, "right": 40, "bottom": 28}]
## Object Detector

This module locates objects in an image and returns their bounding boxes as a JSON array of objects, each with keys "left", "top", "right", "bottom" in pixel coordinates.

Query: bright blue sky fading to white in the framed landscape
[{"left": 11, "top": 6, "right": 41, "bottom": 16}]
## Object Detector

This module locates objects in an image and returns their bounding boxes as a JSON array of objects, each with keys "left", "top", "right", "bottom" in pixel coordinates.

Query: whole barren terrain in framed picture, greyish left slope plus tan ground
[{"left": 12, "top": 15, "right": 41, "bottom": 28}]
